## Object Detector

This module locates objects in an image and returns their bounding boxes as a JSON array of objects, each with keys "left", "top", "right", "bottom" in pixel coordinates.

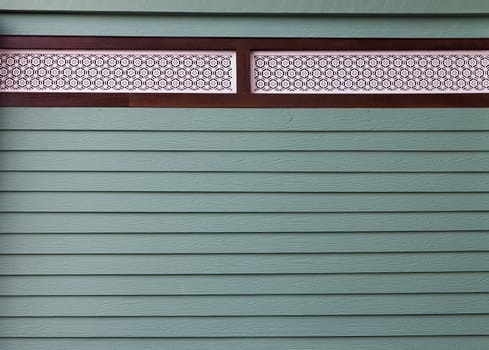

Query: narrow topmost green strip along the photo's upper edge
[{"left": 0, "top": 0, "right": 489, "bottom": 15}]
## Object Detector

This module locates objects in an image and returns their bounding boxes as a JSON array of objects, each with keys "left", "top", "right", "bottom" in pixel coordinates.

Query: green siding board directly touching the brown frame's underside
[{"left": 0, "top": 107, "right": 489, "bottom": 132}]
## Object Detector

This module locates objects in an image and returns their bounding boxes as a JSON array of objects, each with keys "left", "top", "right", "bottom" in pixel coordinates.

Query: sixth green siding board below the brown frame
[{"left": 0, "top": 211, "right": 489, "bottom": 233}]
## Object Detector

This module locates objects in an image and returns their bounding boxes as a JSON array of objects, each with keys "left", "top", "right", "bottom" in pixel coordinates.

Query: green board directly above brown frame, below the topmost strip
[{"left": 0, "top": 13, "right": 489, "bottom": 39}]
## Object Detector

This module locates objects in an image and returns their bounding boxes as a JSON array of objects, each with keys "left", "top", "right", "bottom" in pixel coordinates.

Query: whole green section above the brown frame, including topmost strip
[{"left": 0, "top": 0, "right": 489, "bottom": 38}]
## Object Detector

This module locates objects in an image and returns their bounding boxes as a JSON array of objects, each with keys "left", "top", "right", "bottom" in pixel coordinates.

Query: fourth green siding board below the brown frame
[{"left": 0, "top": 171, "right": 489, "bottom": 193}]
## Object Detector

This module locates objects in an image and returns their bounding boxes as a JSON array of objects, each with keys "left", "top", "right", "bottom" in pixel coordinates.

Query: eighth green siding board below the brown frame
[{"left": 0, "top": 252, "right": 489, "bottom": 275}]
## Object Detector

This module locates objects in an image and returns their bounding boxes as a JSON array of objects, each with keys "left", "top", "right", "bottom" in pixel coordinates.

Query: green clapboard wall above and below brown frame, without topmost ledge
[{"left": 0, "top": 1, "right": 489, "bottom": 350}]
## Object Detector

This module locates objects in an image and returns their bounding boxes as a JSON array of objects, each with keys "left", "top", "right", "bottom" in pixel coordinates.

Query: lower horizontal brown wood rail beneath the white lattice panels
[{"left": 0, "top": 92, "right": 489, "bottom": 108}]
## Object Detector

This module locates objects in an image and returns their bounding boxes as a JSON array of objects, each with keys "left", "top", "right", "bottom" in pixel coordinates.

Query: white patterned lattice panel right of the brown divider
[{"left": 252, "top": 51, "right": 489, "bottom": 94}]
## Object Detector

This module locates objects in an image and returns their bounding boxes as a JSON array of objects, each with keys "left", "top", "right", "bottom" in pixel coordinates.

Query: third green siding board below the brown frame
[{"left": 0, "top": 151, "right": 489, "bottom": 172}]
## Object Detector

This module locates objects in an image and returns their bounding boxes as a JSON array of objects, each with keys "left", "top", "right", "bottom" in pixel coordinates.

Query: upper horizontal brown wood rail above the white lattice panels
[{"left": 0, "top": 36, "right": 489, "bottom": 51}]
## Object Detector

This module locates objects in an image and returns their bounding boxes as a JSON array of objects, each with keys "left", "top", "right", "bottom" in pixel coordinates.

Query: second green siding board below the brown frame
[{"left": 0, "top": 130, "right": 489, "bottom": 151}]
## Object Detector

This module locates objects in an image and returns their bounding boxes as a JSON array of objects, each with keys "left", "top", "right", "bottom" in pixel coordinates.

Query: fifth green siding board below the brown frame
[{"left": 0, "top": 192, "right": 489, "bottom": 213}]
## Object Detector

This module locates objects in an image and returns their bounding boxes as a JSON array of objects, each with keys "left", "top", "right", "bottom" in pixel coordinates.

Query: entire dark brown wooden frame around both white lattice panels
[{"left": 0, "top": 36, "right": 489, "bottom": 108}]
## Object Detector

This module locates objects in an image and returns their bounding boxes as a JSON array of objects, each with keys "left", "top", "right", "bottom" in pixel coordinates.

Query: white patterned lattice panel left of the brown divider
[{"left": 0, "top": 50, "right": 236, "bottom": 93}]
